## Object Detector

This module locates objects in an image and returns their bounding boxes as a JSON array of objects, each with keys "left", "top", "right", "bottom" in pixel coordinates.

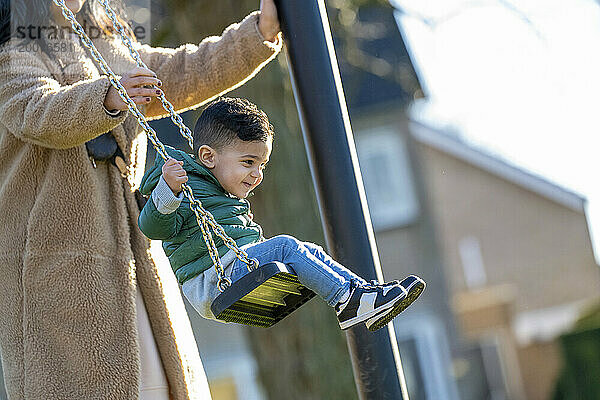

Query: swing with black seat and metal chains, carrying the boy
[{"left": 53, "top": 0, "right": 315, "bottom": 328}]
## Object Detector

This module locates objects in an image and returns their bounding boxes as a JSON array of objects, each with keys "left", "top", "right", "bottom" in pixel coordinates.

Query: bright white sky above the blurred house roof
[{"left": 392, "top": 0, "right": 600, "bottom": 260}]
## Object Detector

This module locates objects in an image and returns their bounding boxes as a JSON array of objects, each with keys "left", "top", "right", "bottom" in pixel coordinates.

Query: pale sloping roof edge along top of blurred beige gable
[{"left": 409, "top": 121, "right": 586, "bottom": 213}]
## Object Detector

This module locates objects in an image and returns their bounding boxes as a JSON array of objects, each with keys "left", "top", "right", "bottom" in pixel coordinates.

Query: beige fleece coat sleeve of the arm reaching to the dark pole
[{"left": 137, "top": 12, "right": 282, "bottom": 118}]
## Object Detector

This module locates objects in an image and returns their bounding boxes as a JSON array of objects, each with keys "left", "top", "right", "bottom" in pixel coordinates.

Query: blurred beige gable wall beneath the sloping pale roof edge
[{"left": 413, "top": 124, "right": 600, "bottom": 312}]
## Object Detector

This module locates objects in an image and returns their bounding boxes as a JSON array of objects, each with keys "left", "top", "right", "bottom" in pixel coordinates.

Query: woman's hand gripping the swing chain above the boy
[{"left": 104, "top": 67, "right": 162, "bottom": 111}]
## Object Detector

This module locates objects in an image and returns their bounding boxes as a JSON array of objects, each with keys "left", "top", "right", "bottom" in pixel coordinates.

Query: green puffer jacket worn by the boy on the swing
[{"left": 138, "top": 146, "right": 262, "bottom": 284}]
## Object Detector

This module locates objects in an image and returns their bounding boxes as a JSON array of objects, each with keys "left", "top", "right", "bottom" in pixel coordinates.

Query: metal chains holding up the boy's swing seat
[{"left": 53, "top": 0, "right": 258, "bottom": 292}]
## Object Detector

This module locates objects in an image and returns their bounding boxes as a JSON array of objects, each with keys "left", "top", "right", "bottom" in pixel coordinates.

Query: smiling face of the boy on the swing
[{"left": 198, "top": 138, "right": 273, "bottom": 199}]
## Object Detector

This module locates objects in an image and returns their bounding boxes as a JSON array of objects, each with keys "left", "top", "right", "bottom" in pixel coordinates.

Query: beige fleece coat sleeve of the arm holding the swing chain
[{"left": 0, "top": 44, "right": 126, "bottom": 149}]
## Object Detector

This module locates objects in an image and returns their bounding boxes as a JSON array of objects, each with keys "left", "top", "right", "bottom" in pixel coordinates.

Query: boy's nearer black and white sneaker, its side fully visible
[{"left": 335, "top": 281, "right": 406, "bottom": 329}]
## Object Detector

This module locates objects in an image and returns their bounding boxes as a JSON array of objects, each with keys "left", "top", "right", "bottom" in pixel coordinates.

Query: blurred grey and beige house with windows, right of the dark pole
[{"left": 353, "top": 112, "right": 600, "bottom": 400}]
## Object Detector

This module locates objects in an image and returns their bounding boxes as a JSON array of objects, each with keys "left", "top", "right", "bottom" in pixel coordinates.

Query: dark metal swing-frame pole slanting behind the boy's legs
[{"left": 275, "top": 0, "right": 408, "bottom": 400}]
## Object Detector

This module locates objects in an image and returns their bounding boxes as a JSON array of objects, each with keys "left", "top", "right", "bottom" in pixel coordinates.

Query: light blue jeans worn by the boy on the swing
[{"left": 231, "top": 235, "right": 367, "bottom": 307}]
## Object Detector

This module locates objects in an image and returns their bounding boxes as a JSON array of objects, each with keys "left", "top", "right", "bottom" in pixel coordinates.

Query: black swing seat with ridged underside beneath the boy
[{"left": 210, "top": 261, "right": 315, "bottom": 328}]
